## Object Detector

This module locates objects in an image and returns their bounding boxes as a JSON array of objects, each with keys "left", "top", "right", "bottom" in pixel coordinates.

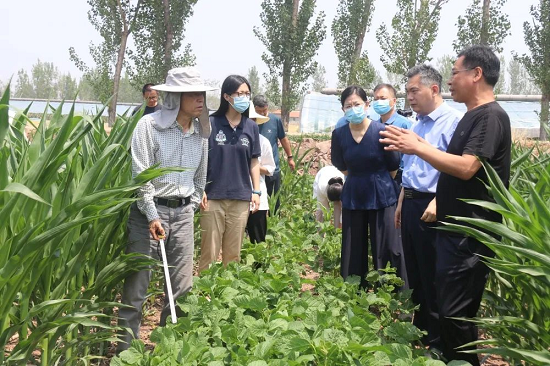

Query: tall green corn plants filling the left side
[{"left": 0, "top": 86, "right": 165, "bottom": 365}]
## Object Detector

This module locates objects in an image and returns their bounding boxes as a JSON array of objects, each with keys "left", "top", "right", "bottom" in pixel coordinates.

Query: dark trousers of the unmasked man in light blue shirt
[{"left": 401, "top": 197, "right": 441, "bottom": 349}]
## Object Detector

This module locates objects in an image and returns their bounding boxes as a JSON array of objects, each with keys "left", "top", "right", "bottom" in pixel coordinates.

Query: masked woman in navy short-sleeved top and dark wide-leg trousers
[{"left": 331, "top": 86, "right": 407, "bottom": 288}]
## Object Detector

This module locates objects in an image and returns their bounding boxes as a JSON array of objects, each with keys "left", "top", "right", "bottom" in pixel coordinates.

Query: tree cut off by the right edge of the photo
[{"left": 515, "top": 0, "right": 550, "bottom": 140}]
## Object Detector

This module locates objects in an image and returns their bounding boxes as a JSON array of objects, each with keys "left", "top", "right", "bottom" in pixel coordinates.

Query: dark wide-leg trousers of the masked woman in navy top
[{"left": 340, "top": 205, "right": 408, "bottom": 289}]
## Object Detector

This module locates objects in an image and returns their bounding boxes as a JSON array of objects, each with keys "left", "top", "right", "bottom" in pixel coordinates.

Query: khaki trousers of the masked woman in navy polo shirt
[{"left": 199, "top": 200, "right": 250, "bottom": 272}]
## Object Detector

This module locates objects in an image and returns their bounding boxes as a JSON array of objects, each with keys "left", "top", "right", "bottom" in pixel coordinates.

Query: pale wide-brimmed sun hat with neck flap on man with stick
[{"left": 151, "top": 67, "right": 218, "bottom": 138}]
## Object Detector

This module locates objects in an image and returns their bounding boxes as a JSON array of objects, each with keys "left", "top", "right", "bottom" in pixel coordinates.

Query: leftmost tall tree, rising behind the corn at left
[{"left": 69, "top": 0, "right": 145, "bottom": 125}]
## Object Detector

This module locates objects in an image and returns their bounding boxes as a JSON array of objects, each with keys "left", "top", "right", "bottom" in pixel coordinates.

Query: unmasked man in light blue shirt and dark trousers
[{"left": 395, "top": 65, "right": 462, "bottom": 350}]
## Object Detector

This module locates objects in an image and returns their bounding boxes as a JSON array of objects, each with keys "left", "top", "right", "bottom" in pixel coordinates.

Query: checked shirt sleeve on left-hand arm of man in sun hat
[{"left": 131, "top": 119, "right": 159, "bottom": 222}]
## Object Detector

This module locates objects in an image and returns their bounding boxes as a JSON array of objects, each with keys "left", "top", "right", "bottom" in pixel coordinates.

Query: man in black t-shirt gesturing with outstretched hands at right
[{"left": 381, "top": 46, "right": 511, "bottom": 365}]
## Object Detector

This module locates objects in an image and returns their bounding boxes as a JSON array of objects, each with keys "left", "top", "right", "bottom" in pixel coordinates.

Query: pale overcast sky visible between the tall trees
[{"left": 0, "top": 0, "right": 538, "bottom": 87}]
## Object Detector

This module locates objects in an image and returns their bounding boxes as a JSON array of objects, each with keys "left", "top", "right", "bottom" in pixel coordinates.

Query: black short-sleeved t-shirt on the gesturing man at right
[{"left": 436, "top": 102, "right": 512, "bottom": 225}]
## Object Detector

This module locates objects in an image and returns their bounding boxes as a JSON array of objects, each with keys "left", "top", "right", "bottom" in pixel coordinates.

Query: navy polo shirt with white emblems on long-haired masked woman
[{"left": 205, "top": 116, "right": 262, "bottom": 201}]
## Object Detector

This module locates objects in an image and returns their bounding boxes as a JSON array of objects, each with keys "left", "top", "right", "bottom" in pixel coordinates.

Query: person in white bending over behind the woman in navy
[{"left": 313, "top": 165, "right": 344, "bottom": 228}]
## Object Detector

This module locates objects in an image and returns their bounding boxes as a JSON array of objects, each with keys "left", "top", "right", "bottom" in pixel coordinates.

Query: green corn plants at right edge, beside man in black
[{"left": 444, "top": 144, "right": 550, "bottom": 365}]
